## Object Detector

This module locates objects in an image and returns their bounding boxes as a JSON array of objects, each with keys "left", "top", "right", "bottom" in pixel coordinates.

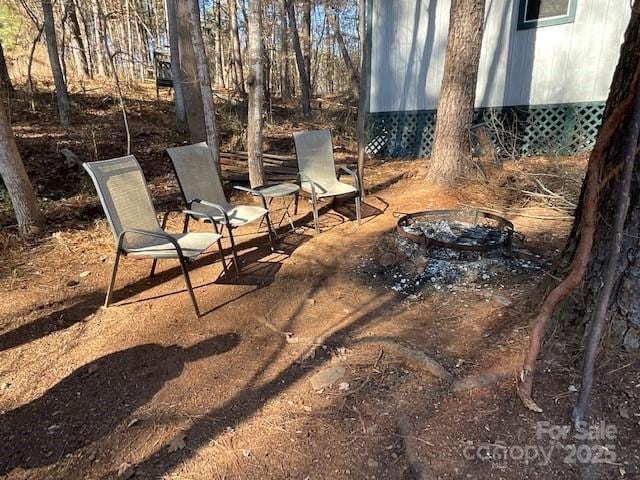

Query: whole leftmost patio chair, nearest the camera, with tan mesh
[{"left": 83, "top": 155, "right": 227, "bottom": 317}]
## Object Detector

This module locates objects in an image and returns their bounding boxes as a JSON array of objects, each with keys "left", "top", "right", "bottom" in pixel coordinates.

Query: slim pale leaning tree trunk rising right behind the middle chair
[{"left": 186, "top": 0, "right": 220, "bottom": 172}]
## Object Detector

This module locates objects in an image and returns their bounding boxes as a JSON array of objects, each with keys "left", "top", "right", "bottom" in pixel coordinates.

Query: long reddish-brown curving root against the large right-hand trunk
[{"left": 518, "top": 70, "right": 638, "bottom": 412}]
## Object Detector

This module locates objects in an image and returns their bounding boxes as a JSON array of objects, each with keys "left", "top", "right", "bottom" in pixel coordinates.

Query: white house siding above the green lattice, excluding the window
[{"left": 369, "top": 0, "right": 630, "bottom": 113}]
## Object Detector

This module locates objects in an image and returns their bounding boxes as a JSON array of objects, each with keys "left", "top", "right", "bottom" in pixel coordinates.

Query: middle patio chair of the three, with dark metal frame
[{"left": 167, "top": 142, "right": 275, "bottom": 274}]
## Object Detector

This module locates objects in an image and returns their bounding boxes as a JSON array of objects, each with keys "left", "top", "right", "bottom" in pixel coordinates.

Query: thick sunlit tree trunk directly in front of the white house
[{"left": 427, "top": 0, "right": 485, "bottom": 184}]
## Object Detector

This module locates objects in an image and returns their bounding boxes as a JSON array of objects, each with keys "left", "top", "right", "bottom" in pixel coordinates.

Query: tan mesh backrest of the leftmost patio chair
[{"left": 82, "top": 155, "right": 161, "bottom": 248}]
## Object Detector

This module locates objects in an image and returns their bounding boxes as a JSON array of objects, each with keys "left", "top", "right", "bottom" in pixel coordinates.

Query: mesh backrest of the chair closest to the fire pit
[{"left": 293, "top": 130, "right": 336, "bottom": 183}]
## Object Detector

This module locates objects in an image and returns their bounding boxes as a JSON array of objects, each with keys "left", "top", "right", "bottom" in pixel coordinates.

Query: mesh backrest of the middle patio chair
[{"left": 167, "top": 142, "right": 229, "bottom": 208}]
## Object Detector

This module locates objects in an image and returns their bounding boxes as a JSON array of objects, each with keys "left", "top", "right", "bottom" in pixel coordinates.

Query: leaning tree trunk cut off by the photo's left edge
[{"left": 0, "top": 101, "right": 43, "bottom": 234}]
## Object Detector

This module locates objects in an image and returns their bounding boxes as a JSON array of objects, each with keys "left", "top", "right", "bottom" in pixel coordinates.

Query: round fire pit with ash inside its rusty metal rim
[{"left": 397, "top": 210, "right": 513, "bottom": 252}]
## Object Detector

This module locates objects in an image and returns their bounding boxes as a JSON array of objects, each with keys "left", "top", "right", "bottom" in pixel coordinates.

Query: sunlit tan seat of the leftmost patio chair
[{"left": 125, "top": 232, "right": 222, "bottom": 258}]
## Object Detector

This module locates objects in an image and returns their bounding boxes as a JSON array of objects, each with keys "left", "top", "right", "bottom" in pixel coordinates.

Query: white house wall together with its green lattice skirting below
[{"left": 367, "top": 0, "right": 631, "bottom": 157}]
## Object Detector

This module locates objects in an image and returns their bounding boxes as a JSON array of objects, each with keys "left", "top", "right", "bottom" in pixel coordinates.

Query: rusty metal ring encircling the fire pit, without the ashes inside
[{"left": 396, "top": 210, "right": 514, "bottom": 252}]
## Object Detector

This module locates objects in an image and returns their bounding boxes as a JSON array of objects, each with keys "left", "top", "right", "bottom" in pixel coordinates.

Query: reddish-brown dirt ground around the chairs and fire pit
[{"left": 0, "top": 84, "right": 640, "bottom": 480}]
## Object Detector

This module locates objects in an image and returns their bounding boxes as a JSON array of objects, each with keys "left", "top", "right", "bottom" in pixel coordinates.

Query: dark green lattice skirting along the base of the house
[{"left": 367, "top": 102, "right": 604, "bottom": 158}]
